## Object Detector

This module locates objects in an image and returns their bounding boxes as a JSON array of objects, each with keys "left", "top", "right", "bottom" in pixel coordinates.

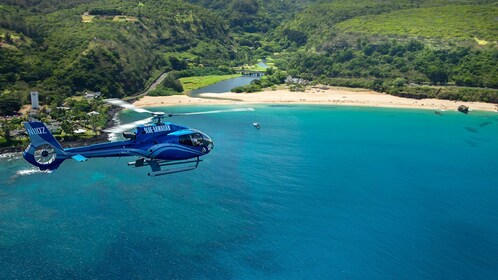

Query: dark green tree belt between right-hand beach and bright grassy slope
[{"left": 280, "top": 39, "right": 498, "bottom": 99}]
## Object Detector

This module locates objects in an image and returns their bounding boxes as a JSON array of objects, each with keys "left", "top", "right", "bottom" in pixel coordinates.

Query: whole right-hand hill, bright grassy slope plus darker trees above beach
[{"left": 273, "top": 0, "right": 498, "bottom": 102}]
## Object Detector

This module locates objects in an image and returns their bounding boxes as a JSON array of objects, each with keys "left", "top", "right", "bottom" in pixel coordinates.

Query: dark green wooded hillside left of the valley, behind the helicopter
[{"left": 0, "top": 0, "right": 236, "bottom": 104}]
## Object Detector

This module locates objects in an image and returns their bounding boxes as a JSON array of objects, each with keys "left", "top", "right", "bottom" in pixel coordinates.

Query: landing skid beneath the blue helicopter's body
[{"left": 128, "top": 157, "right": 202, "bottom": 177}]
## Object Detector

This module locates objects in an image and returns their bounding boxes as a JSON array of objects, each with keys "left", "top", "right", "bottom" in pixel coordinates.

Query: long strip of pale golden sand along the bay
[{"left": 134, "top": 87, "right": 498, "bottom": 112}]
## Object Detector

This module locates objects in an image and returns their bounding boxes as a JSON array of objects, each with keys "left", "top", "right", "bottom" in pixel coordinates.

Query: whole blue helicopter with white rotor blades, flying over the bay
[{"left": 23, "top": 99, "right": 254, "bottom": 176}]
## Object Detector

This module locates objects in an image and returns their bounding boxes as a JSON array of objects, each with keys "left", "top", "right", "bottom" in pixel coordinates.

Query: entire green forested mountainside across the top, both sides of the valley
[{"left": 0, "top": 0, "right": 498, "bottom": 108}]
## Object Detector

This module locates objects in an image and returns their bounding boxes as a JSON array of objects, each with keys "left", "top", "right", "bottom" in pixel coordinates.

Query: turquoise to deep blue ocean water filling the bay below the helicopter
[{"left": 0, "top": 106, "right": 498, "bottom": 279}]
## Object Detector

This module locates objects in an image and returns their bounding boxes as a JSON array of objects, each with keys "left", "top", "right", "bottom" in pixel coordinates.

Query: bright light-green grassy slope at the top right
[{"left": 335, "top": 5, "right": 498, "bottom": 43}]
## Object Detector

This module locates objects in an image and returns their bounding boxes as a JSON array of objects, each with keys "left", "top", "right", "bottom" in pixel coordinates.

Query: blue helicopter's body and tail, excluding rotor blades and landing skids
[{"left": 23, "top": 122, "right": 213, "bottom": 174}]
